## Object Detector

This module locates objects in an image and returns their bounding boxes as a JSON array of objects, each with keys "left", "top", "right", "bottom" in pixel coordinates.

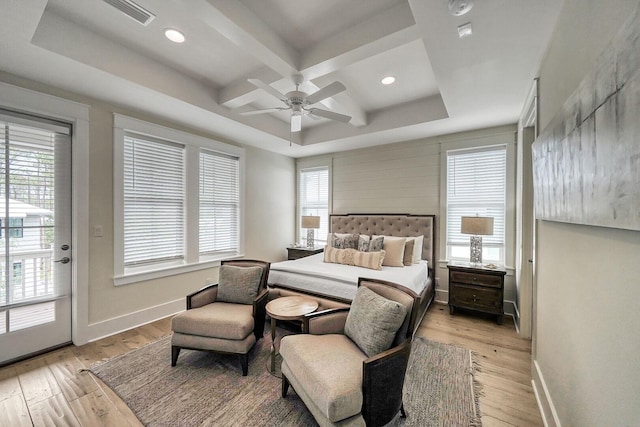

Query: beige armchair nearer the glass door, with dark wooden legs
[{"left": 171, "top": 259, "right": 271, "bottom": 376}]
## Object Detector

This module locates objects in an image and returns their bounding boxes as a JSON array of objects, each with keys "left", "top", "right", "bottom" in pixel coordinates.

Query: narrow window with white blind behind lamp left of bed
[{"left": 298, "top": 166, "right": 329, "bottom": 244}]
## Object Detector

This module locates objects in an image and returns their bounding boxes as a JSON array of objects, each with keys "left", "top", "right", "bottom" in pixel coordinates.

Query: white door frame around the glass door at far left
[{"left": 0, "top": 82, "right": 89, "bottom": 345}]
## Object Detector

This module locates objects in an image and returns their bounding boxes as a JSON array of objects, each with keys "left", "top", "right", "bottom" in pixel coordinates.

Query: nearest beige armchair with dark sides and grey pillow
[{"left": 280, "top": 278, "right": 419, "bottom": 426}]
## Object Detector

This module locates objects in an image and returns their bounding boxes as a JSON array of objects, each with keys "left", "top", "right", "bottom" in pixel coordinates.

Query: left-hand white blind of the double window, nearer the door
[{"left": 124, "top": 134, "right": 185, "bottom": 267}]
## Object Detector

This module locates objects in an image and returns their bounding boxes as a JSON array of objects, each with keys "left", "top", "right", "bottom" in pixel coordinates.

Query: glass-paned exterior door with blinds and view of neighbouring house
[{"left": 0, "top": 109, "right": 73, "bottom": 364}]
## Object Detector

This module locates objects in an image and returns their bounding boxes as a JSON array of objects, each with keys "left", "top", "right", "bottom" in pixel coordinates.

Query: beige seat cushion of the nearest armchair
[{"left": 280, "top": 334, "right": 367, "bottom": 422}]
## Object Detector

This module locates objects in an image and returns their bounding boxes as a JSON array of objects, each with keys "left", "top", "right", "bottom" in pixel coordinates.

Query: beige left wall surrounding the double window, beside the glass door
[{"left": 0, "top": 73, "right": 295, "bottom": 340}]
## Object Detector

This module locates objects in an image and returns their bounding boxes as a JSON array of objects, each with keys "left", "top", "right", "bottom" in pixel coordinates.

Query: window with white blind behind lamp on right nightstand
[{"left": 446, "top": 145, "right": 507, "bottom": 264}]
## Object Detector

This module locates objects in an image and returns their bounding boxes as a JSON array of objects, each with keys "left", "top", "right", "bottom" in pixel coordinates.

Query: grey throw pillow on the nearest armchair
[{"left": 344, "top": 286, "right": 407, "bottom": 357}]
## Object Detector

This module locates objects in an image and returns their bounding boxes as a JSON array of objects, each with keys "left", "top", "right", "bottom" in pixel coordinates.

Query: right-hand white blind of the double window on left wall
[{"left": 199, "top": 151, "right": 240, "bottom": 256}]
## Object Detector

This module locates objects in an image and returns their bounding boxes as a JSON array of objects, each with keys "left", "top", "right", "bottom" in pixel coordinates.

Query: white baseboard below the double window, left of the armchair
[{"left": 88, "top": 298, "right": 186, "bottom": 341}]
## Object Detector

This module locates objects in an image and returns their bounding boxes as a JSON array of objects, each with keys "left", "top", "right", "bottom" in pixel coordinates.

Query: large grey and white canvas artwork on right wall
[{"left": 532, "top": 4, "right": 640, "bottom": 230}]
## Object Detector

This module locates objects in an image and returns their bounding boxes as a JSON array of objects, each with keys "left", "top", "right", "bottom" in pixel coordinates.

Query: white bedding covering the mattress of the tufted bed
[{"left": 269, "top": 253, "right": 428, "bottom": 300}]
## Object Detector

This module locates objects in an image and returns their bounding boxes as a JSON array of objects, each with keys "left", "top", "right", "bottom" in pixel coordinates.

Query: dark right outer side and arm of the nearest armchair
[{"left": 362, "top": 339, "right": 411, "bottom": 425}]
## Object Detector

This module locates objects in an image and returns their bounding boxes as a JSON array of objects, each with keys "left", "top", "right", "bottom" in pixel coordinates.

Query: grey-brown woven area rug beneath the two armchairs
[{"left": 90, "top": 336, "right": 481, "bottom": 427}]
